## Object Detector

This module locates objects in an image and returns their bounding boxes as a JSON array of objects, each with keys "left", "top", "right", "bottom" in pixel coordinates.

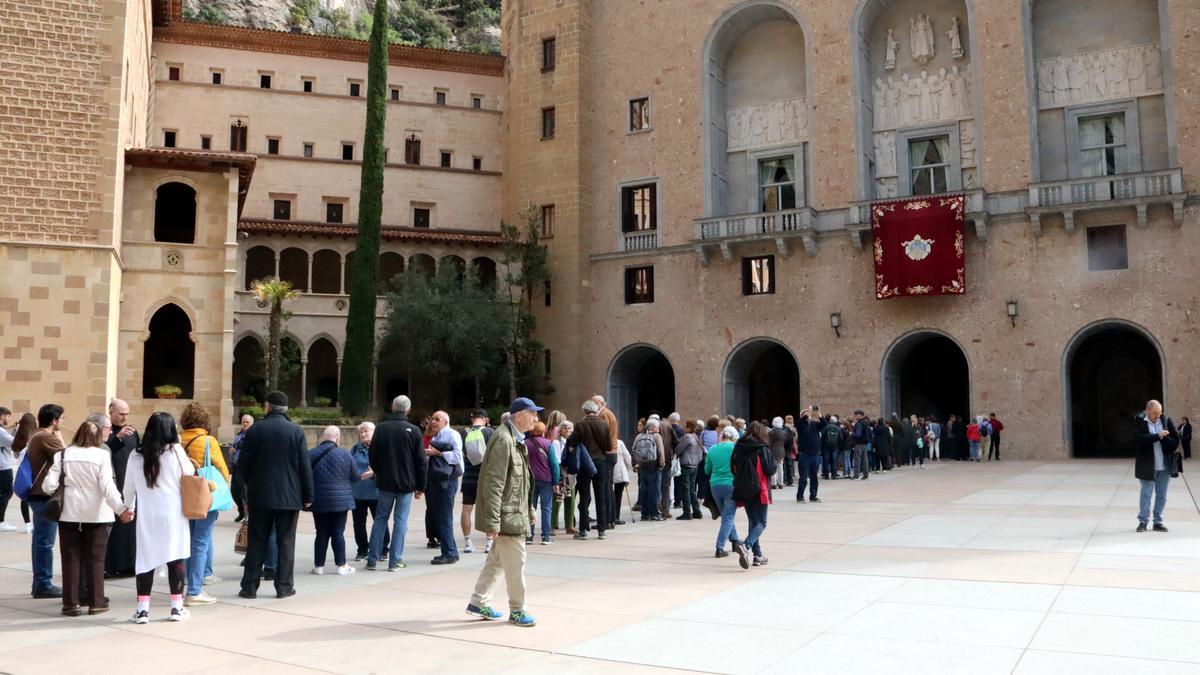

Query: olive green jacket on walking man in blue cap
[{"left": 475, "top": 423, "right": 532, "bottom": 537}]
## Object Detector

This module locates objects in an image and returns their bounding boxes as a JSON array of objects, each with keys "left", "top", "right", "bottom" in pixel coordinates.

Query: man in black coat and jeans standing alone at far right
[{"left": 1133, "top": 401, "right": 1180, "bottom": 532}]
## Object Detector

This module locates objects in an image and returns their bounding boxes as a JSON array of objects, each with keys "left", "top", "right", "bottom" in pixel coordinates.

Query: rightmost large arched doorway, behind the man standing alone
[{"left": 1063, "top": 321, "right": 1165, "bottom": 458}]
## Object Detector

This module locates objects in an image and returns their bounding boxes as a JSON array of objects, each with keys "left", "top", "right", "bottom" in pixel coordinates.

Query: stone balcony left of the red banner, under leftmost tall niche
[{"left": 692, "top": 207, "right": 817, "bottom": 264}]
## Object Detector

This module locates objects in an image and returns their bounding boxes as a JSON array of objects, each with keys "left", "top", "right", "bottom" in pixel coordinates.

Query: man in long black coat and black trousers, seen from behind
[{"left": 238, "top": 392, "right": 312, "bottom": 598}]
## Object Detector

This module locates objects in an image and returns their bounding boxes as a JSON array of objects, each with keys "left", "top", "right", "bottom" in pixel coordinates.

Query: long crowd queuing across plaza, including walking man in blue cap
[{"left": 0, "top": 392, "right": 1003, "bottom": 626}]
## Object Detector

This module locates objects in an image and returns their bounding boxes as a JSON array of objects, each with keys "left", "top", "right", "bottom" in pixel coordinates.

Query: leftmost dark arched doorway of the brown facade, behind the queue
[{"left": 607, "top": 345, "right": 676, "bottom": 443}]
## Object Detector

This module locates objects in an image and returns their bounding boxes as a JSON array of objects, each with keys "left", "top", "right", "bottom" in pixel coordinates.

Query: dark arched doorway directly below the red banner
[{"left": 881, "top": 330, "right": 971, "bottom": 422}]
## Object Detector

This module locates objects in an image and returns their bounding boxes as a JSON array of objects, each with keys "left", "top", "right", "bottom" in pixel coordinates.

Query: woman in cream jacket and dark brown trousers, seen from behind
[{"left": 42, "top": 416, "right": 133, "bottom": 616}]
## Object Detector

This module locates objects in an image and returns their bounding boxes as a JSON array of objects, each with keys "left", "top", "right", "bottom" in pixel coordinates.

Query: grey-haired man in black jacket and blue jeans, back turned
[{"left": 367, "top": 396, "right": 428, "bottom": 572}]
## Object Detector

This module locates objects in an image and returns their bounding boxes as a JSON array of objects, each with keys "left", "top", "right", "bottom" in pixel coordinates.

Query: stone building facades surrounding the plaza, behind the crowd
[{"left": 0, "top": 0, "right": 1200, "bottom": 458}]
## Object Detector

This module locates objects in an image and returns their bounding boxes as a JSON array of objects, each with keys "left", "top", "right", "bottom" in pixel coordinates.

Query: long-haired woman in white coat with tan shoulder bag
[{"left": 125, "top": 412, "right": 196, "bottom": 623}]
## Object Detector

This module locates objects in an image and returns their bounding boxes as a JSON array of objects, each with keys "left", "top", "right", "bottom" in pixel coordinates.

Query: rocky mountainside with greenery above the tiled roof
[{"left": 184, "top": 0, "right": 500, "bottom": 54}]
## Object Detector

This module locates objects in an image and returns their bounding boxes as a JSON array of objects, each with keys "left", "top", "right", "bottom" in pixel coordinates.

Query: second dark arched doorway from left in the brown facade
[{"left": 722, "top": 338, "right": 800, "bottom": 422}]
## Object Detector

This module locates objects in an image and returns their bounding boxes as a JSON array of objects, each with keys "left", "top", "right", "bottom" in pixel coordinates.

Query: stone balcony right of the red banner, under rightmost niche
[{"left": 1025, "top": 168, "right": 1187, "bottom": 237}]
